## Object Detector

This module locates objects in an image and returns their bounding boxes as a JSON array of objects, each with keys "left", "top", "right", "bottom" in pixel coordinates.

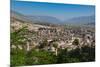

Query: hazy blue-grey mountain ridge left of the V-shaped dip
[{"left": 11, "top": 11, "right": 61, "bottom": 24}]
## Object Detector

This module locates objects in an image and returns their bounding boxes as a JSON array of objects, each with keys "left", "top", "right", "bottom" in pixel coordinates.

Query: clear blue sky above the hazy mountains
[{"left": 11, "top": 0, "right": 95, "bottom": 20}]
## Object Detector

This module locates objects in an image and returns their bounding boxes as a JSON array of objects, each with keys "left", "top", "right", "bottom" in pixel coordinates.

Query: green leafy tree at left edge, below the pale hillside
[{"left": 11, "top": 27, "right": 27, "bottom": 48}]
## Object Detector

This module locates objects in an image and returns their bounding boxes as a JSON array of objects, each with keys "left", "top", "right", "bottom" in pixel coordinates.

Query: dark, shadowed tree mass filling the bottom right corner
[{"left": 57, "top": 46, "right": 95, "bottom": 63}]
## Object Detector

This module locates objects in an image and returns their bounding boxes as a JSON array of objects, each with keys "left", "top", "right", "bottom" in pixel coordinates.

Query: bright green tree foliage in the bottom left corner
[{"left": 10, "top": 49, "right": 26, "bottom": 66}]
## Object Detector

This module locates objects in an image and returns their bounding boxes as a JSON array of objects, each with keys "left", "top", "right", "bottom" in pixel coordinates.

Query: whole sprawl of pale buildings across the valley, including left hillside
[{"left": 11, "top": 21, "right": 95, "bottom": 51}]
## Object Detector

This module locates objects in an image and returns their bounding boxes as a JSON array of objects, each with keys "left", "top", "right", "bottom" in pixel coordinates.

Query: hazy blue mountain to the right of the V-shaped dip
[{"left": 64, "top": 15, "right": 95, "bottom": 24}]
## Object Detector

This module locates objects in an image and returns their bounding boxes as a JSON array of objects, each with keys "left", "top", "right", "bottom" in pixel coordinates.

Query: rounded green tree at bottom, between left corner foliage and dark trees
[{"left": 26, "top": 49, "right": 56, "bottom": 65}]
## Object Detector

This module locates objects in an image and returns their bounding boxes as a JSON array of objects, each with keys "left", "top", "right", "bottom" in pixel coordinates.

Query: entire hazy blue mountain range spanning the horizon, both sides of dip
[{"left": 11, "top": 11, "right": 95, "bottom": 25}]
